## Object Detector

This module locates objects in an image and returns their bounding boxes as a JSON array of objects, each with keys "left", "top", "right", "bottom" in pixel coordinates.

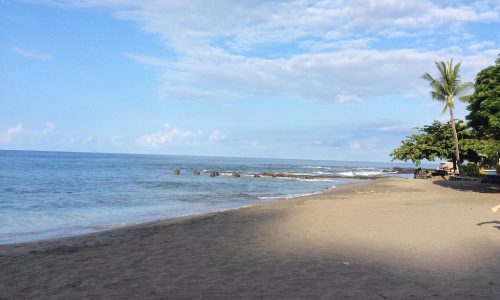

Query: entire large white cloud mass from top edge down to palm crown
[{"left": 41, "top": 0, "right": 500, "bottom": 102}]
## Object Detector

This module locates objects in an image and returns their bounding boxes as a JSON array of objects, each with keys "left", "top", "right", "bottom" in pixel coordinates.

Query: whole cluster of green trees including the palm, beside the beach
[{"left": 390, "top": 56, "right": 500, "bottom": 170}]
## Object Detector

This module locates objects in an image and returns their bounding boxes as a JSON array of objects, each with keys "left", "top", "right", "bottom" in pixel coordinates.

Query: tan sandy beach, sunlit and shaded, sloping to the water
[{"left": 0, "top": 179, "right": 500, "bottom": 299}]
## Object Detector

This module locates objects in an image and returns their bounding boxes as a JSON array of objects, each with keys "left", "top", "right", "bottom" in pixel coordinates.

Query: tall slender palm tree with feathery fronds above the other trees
[{"left": 422, "top": 59, "right": 474, "bottom": 172}]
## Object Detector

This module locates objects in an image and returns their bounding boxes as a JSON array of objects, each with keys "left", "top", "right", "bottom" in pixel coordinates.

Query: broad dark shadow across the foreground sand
[{"left": 0, "top": 204, "right": 500, "bottom": 299}]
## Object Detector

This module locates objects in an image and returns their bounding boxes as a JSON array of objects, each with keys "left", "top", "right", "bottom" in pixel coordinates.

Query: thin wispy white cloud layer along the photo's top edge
[{"left": 65, "top": 0, "right": 500, "bottom": 50}]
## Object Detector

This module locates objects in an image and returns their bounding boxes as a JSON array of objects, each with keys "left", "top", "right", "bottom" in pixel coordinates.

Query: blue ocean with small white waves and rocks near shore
[{"left": 0, "top": 150, "right": 414, "bottom": 244}]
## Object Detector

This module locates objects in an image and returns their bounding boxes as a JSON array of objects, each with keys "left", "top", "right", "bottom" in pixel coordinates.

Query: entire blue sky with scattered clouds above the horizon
[{"left": 0, "top": 0, "right": 500, "bottom": 161}]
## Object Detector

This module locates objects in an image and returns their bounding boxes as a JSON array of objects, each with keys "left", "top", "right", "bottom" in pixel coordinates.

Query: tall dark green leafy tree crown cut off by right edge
[{"left": 466, "top": 58, "right": 500, "bottom": 140}]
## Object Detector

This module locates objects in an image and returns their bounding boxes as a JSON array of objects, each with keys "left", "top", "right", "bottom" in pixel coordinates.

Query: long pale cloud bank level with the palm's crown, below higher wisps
[{"left": 156, "top": 48, "right": 497, "bottom": 102}]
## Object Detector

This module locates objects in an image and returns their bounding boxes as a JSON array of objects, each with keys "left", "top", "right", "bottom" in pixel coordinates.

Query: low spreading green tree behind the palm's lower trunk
[{"left": 390, "top": 120, "right": 474, "bottom": 165}]
